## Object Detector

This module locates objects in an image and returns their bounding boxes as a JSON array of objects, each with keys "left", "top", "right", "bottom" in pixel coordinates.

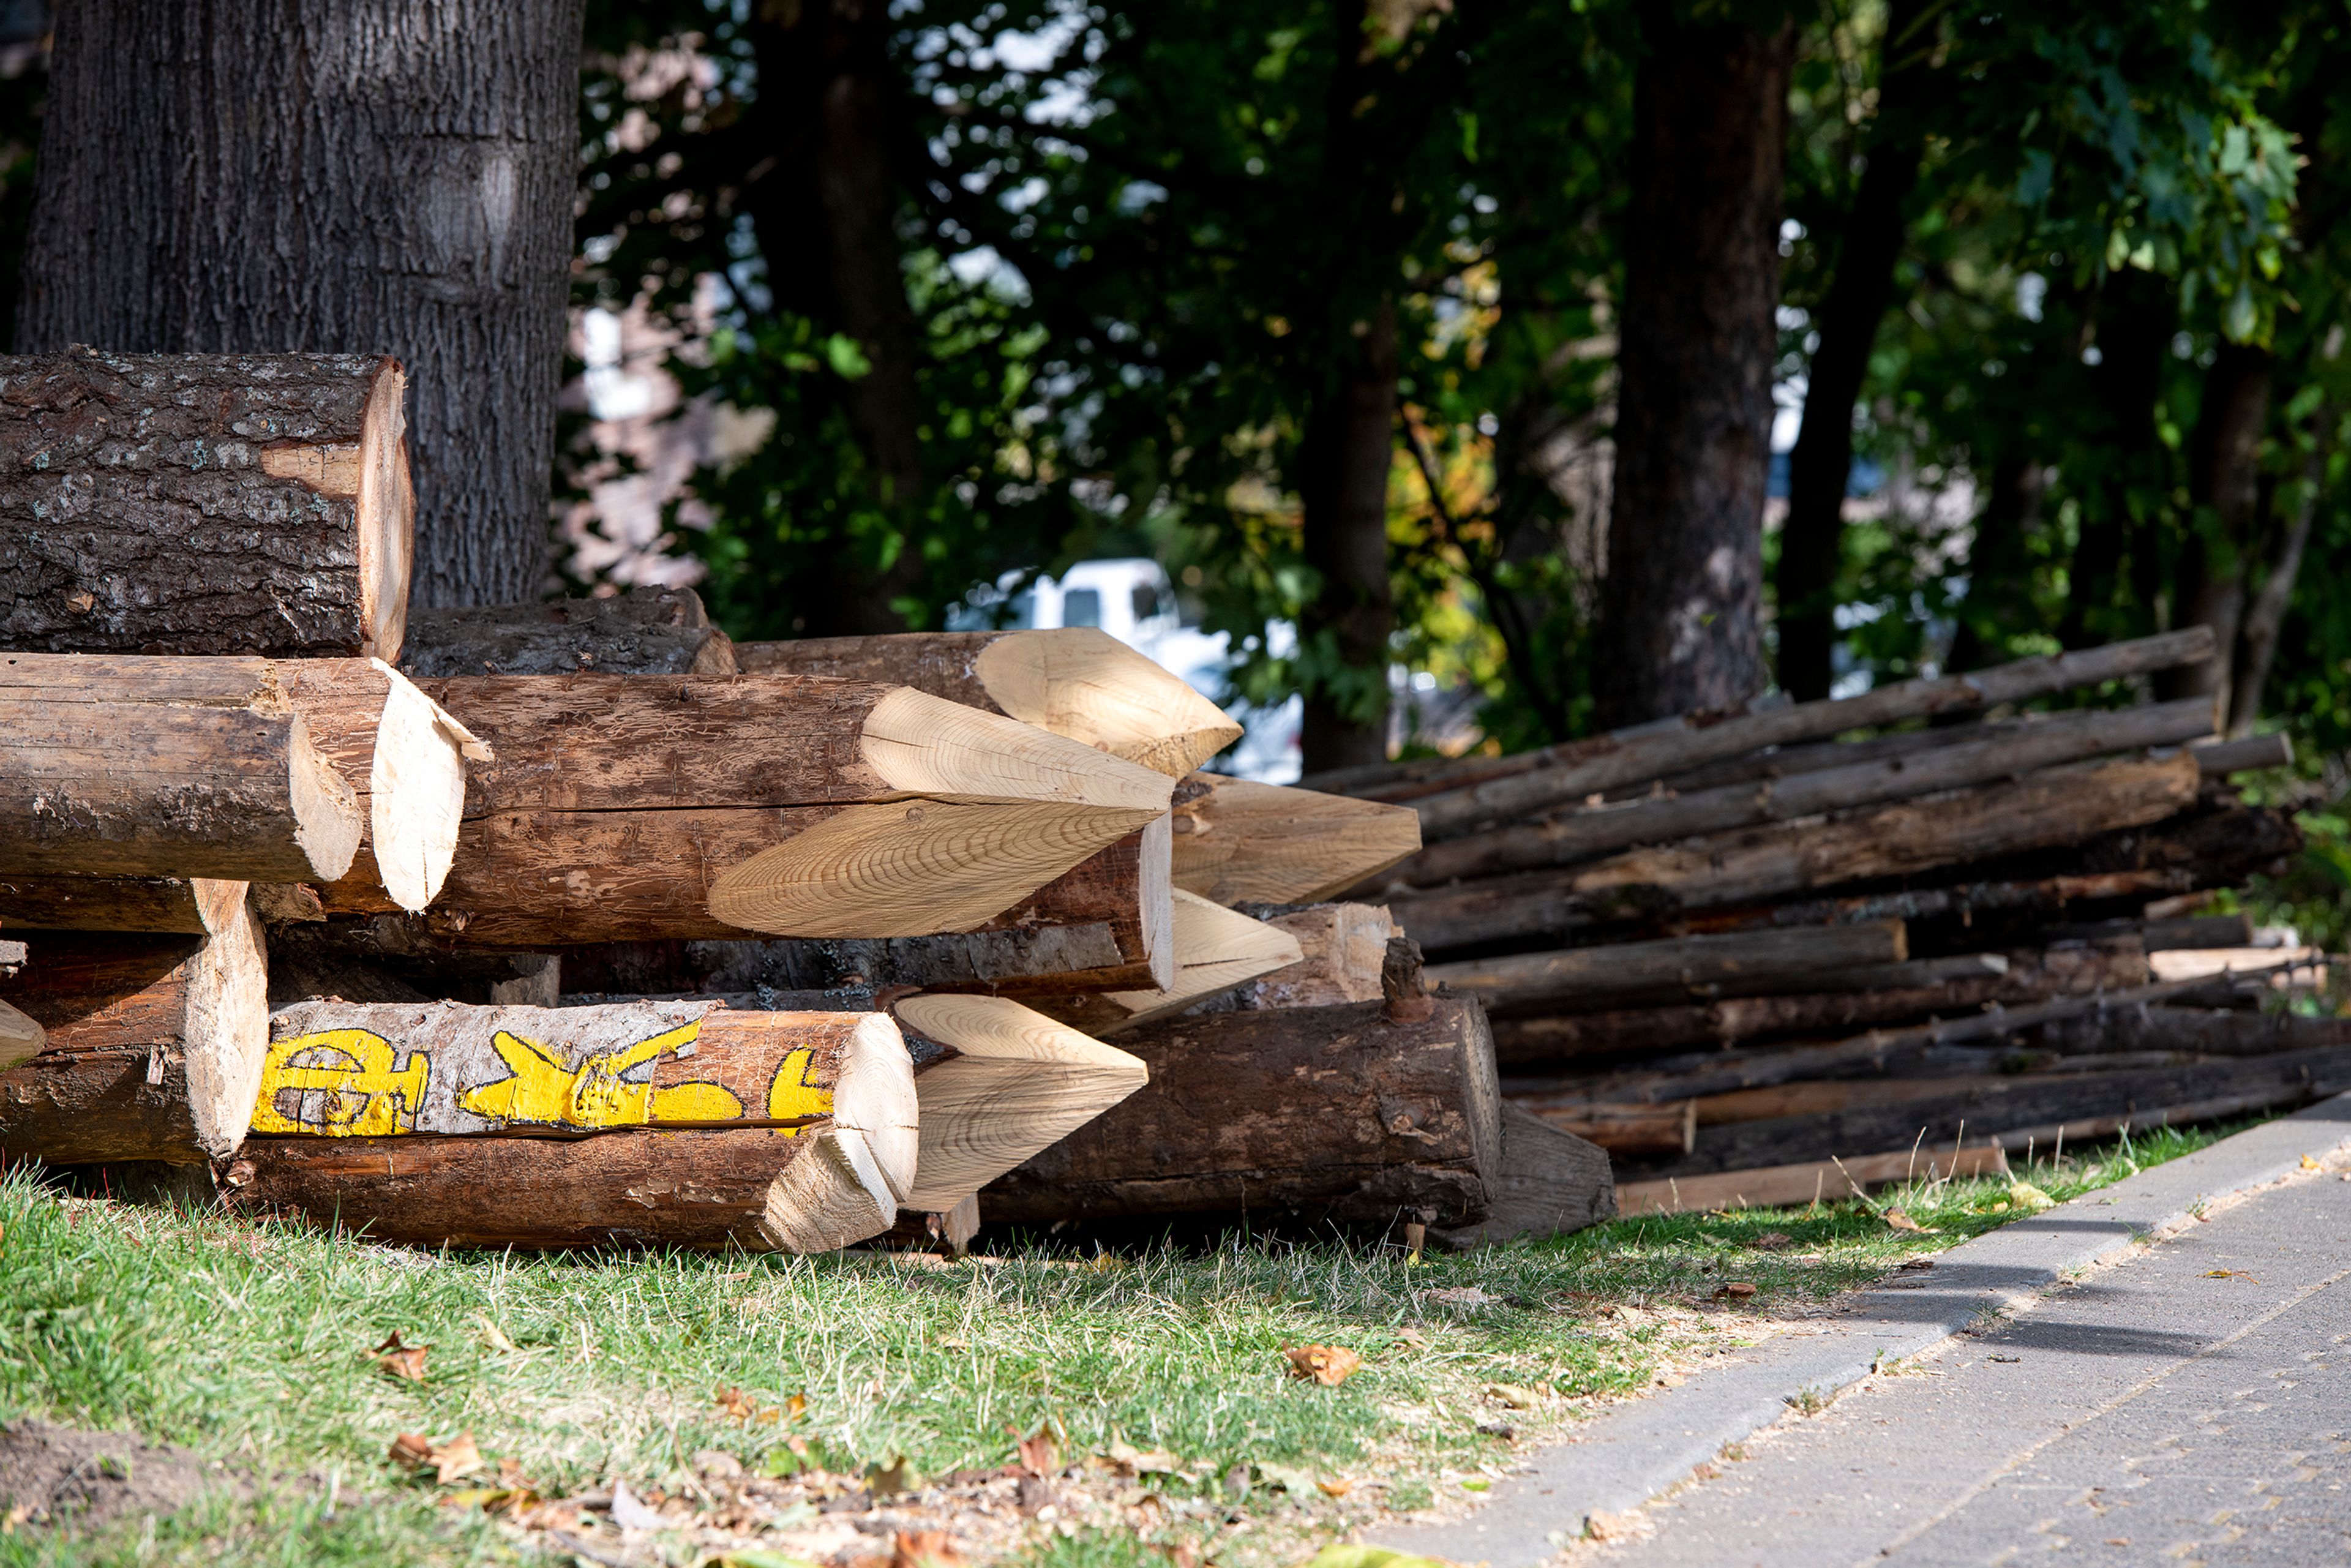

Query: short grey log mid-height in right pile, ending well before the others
[{"left": 1430, "top": 919, "right": 1909, "bottom": 1013}]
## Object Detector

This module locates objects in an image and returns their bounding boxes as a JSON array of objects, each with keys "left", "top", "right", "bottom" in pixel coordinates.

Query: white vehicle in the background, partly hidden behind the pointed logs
[{"left": 948, "top": 557, "right": 1302, "bottom": 783}]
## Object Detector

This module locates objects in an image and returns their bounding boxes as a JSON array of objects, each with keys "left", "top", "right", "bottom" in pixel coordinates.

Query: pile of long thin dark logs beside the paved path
[{"left": 1307, "top": 628, "right": 2351, "bottom": 1210}]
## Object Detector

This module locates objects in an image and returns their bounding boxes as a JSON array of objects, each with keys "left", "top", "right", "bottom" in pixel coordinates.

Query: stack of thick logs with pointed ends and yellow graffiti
[{"left": 0, "top": 350, "right": 1610, "bottom": 1251}]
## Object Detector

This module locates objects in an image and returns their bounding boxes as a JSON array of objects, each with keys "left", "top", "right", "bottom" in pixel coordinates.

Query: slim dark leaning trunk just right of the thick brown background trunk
[{"left": 1777, "top": 0, "right": 1932, "bottom": 703}]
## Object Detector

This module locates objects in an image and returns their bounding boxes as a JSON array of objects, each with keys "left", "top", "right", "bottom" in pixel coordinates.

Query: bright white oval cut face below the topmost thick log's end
[{"left": 367, "top": 658, "right": 492, "bottom": 915}]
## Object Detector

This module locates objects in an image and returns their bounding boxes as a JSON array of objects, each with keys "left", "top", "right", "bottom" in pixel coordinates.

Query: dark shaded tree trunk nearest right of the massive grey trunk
[{"left": 750, "top": 0, "right": 926, "bottom": 635}]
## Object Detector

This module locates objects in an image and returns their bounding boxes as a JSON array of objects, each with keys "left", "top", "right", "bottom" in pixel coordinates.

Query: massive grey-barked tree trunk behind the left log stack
[{"left": 17, "top": 0, "right": 580, "bottom": 604}]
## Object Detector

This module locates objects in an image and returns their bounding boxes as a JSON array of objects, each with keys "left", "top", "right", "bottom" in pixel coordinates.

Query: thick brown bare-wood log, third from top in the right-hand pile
[{"left": 1389, "top": 752, "right": 2198, "bottom": 952}]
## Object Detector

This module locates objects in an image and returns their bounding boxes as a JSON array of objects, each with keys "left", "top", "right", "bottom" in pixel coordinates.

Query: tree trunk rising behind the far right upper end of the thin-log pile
[{"left": 2156, "top": 343, "right": 2278, "bottom": 722}]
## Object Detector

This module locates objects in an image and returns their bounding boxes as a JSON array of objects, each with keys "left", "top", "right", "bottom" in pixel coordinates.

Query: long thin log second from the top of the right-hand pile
[{"left": 1385, "top": 698, "right": 2212, "bottom": 887}]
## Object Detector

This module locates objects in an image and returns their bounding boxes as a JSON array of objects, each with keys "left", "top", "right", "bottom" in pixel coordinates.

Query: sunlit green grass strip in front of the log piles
[{"left": 0, "top": 1133, "right": 2212, "bottom": 1568}]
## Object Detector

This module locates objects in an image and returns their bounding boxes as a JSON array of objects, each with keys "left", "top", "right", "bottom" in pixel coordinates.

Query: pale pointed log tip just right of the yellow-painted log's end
[{"left": 898, "top": 994, "right": 1150, "bottom": 1213}]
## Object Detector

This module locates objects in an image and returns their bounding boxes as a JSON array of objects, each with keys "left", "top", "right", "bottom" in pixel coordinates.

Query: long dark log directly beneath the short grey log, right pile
[{"left": 1493, "top": 940, "right": 2149, "bottom": 1065}]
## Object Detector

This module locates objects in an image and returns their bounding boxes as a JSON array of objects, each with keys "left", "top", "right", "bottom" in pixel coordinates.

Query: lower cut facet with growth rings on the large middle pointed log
[{"left": 710, "top": 799, "right": 1159, "bottom": 936}]
